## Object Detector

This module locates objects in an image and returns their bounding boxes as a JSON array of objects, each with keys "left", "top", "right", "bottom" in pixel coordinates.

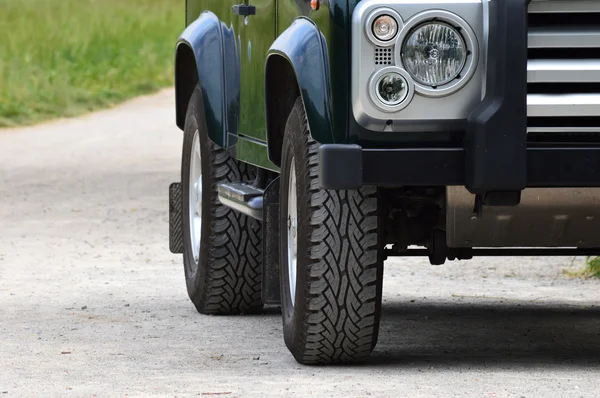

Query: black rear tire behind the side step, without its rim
[{"left": 181, "top": 87, "right": 263, "bottom": 315}]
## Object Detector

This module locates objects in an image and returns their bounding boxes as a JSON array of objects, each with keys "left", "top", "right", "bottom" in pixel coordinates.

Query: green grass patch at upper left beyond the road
[{"left": 0, "top": 0, "right": 185, "bottom": 127}]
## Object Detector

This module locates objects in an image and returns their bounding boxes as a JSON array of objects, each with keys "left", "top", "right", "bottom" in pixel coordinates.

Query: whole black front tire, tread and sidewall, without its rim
[{"left": 280, "top": 98, "right": 383, "bottom": 365}]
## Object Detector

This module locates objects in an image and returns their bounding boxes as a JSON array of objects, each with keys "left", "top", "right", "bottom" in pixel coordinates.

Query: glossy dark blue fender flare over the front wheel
[{"left": 265, "top": 17, "right": 335, "bottom": 166}]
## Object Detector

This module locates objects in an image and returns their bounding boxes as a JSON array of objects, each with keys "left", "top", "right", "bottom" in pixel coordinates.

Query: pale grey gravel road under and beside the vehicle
[{"left": 0, "top": 91, "right": 600, "bottom": 398}]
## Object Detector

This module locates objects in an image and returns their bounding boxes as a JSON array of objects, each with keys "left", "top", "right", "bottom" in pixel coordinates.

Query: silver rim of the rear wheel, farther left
[{"left": 189, "top": 130, "right": 202, "bottom": 264}]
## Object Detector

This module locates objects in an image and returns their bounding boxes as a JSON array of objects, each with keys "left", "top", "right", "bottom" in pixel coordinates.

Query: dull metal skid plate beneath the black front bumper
[{"left": 446, "top": 187, "right": 600, "bottom": 248}]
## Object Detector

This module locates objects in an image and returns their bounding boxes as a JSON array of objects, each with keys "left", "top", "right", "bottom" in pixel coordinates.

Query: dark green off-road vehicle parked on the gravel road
[{"left": 170, "top": 0, "right": 600, "bottom": 364}]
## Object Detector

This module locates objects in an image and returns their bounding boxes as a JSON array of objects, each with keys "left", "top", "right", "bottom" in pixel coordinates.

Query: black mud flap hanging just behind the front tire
[{"left": 262, "top": 177, "right": 281, "bottom": 305}]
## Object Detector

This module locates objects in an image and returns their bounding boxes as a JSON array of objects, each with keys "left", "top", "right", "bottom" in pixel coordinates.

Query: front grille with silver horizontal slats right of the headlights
[{"left": 527, "top": 0, "right": 600, "bottom": 137}]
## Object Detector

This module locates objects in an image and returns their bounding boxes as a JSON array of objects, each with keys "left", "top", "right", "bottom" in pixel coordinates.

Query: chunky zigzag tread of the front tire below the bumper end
[{"left": 292, "top": 100, "right": 383, "bottom": 365}]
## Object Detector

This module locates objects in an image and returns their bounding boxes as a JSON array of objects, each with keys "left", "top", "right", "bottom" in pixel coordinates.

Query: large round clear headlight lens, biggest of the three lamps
[{"left": 402, "top": 22, "right": 468, "bottom": 87}]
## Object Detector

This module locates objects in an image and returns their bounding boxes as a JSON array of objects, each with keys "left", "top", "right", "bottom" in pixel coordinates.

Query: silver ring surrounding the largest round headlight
[{"left": 395, "top": 10, "right": 479, "bottom": 97}]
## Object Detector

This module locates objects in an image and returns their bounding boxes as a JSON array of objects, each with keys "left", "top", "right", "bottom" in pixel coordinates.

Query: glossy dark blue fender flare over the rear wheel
[{"left": 175, "top": 11, "right": 239, "bottom": 147}]
